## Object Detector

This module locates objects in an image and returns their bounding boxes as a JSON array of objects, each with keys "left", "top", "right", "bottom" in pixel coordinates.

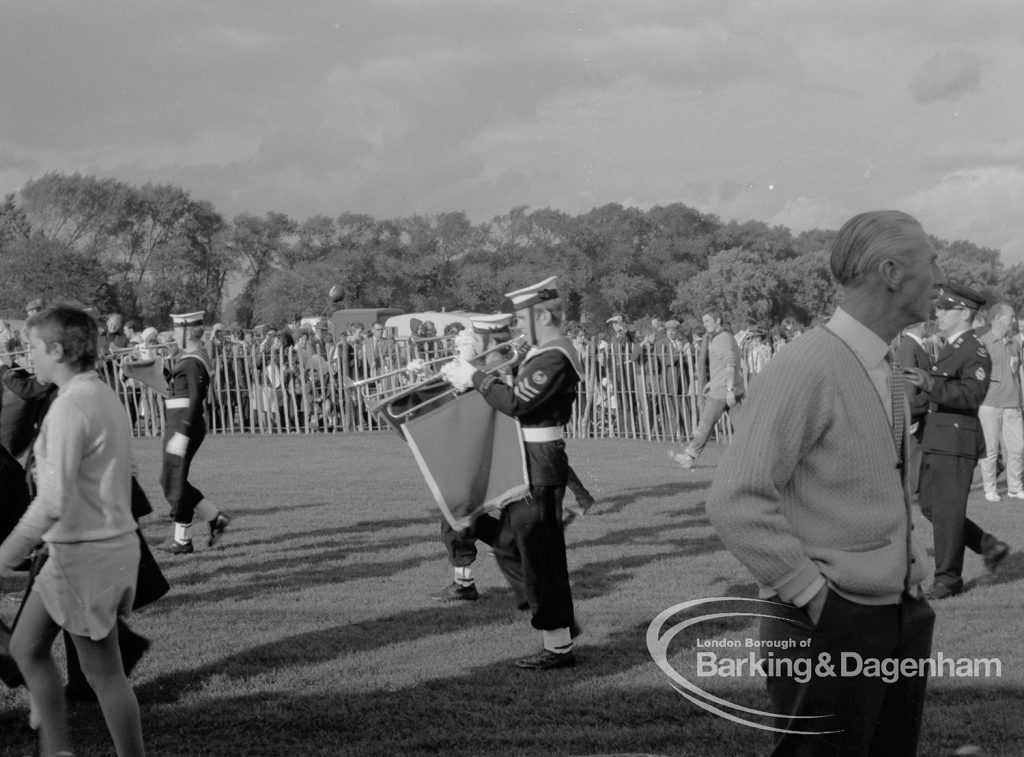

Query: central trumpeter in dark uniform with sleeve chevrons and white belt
[{"left": 441, "top": 277, "right": 583, "bottom": 670}]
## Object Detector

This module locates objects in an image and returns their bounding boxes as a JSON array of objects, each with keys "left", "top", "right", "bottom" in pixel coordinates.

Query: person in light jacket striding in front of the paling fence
[{"left": 669, "top": 308, "right": 743, "bottom": 470}]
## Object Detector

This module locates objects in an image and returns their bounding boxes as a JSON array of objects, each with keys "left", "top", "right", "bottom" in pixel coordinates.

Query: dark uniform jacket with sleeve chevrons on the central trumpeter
[{"left": 473, "top": 337, "right": 583, "bottom": 487}]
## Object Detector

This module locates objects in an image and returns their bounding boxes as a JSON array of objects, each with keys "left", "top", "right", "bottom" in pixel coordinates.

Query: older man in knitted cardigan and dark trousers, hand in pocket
[{"left": 708, "top": 211, "right": 942, "bottom": 755}]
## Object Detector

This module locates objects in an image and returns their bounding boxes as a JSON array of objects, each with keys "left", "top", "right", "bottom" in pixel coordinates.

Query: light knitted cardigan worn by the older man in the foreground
[{"left": 707, "top": 328, "right": 926, "bottom": 604}]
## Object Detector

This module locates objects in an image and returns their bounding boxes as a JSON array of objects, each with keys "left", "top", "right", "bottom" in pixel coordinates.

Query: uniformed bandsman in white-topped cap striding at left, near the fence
[{"left": 160, "top": 310, "right": 230, "bottom": 554}]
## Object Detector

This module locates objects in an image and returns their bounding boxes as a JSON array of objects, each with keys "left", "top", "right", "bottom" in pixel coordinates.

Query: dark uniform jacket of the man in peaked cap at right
[{"left": 921, "top": 330, "right": 992, "bottom": 460}]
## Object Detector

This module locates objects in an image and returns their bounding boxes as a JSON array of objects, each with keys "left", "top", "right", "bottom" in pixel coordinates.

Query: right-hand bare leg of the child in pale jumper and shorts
[{"left": 72, "top": 626, "right": 145, "bottom": 757}]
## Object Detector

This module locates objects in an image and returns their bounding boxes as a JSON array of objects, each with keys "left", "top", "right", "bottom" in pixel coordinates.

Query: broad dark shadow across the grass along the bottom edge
[{"left": 8, "top": 671, "right": 1024, "bottom": 757}]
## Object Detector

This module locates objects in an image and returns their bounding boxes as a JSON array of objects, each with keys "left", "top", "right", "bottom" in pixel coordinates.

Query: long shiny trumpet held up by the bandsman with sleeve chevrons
[{"left": 347, "top": 336, "right": 526, "bottom": 422}]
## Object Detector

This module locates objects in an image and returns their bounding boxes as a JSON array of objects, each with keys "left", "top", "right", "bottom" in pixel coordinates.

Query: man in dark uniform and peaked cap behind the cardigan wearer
[{"left": 907, "top": 282, "right": 1010, "bottom": 600}]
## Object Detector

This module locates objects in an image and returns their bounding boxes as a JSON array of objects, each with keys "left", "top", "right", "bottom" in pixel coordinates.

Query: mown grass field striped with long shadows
[{"left": 0, "top": 433, "right": 1024, "bottom": 757}]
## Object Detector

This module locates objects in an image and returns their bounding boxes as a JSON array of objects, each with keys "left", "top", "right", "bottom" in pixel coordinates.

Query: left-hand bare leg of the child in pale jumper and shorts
[{"left": 10, "top": 592, "right": 71, "bottom": 755}]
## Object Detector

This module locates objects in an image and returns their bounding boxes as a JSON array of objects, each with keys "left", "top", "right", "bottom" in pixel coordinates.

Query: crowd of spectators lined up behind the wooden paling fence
[{"left": 6, "top": 301, "right": 1021, "bottom": 439}]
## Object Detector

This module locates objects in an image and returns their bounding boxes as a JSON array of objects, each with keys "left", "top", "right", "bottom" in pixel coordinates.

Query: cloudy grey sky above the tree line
[{"left": 0, "top": 0, "right": 1024, "bottom": 262}]
